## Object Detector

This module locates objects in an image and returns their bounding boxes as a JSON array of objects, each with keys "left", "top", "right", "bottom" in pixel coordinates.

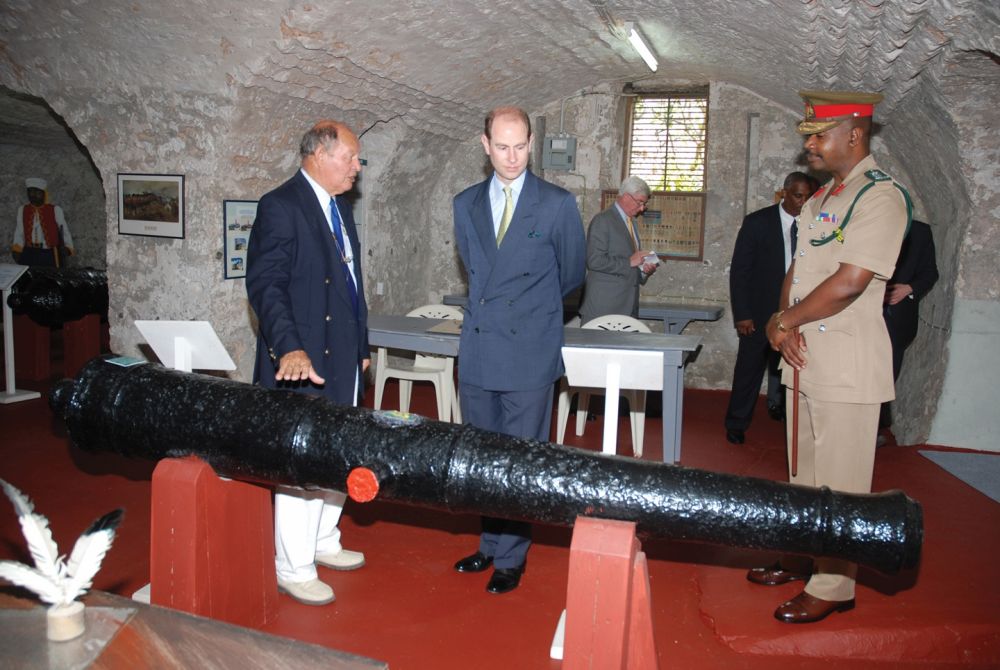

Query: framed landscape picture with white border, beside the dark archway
[{"left": 118, "top": 173, "right": 184, "bottom": 239}]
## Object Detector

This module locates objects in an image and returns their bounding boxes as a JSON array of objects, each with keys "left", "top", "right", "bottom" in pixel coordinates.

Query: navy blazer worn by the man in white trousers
[{"left": 246, "top": 171, "right": 369, "bottom": 404}]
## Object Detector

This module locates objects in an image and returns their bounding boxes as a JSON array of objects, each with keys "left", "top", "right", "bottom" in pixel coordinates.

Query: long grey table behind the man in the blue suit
[{"left": 368, "top": 314, "right": 701, "bottom": 463}]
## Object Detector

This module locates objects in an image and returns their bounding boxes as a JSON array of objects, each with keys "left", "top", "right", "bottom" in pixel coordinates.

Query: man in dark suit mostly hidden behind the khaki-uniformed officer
[{"left": 878, "top": 220, "right": 938, "bottom": 438}]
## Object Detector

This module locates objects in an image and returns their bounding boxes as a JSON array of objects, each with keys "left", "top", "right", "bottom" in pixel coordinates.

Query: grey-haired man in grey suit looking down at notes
[{"left": 580, "top": 176, "right": 657, "bottom": 323}]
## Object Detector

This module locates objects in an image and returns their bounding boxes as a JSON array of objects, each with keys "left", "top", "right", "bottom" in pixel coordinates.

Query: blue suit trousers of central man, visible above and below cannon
[{"left": 459, "top": 384, "right": 552, "bottom": 570}]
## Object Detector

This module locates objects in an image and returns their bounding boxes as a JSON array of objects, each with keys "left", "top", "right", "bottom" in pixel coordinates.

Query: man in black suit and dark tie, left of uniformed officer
[{"left": 726, "top": 172, "right": 819, "bottom": 444}]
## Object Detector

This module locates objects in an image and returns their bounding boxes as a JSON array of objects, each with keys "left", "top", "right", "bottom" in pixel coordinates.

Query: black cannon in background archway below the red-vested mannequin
[{"left": 7, "top": 266, "right": 108, "bottom": 326}]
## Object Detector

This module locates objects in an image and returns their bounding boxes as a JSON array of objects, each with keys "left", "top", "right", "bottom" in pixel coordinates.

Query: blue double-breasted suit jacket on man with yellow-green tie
[{"left": 454, "top": 172, "right": 587, "bottom": 391}]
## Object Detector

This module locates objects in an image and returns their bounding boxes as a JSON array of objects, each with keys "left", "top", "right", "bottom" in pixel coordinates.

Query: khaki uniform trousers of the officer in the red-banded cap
[{"left": 786, "top": 389, "right": 879, "bottom": 601}]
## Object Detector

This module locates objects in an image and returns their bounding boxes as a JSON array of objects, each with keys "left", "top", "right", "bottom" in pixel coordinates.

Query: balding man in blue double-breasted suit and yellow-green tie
[{"left": 454, "top": 107, "right": 586, "bottom": 593}]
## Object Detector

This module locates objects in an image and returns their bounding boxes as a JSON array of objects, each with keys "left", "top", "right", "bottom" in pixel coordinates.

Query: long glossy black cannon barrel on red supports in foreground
[{"left": 49, "top": 358, "right": 923, "bottom": 572}]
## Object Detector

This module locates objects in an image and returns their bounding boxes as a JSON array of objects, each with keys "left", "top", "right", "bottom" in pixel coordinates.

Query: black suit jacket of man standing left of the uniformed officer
[{"left": 729, "top": 204, "right": 785, "bottom": 330}]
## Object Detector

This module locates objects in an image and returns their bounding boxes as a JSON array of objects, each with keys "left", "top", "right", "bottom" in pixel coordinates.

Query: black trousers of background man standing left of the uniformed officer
[{"left": 726, "top": 328, "right": 785, "bottom": 430}]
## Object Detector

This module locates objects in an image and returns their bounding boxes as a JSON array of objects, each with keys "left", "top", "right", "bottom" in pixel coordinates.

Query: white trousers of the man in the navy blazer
[{"left": 274, "top": 371, "right": 361, "bottom": 582}]
